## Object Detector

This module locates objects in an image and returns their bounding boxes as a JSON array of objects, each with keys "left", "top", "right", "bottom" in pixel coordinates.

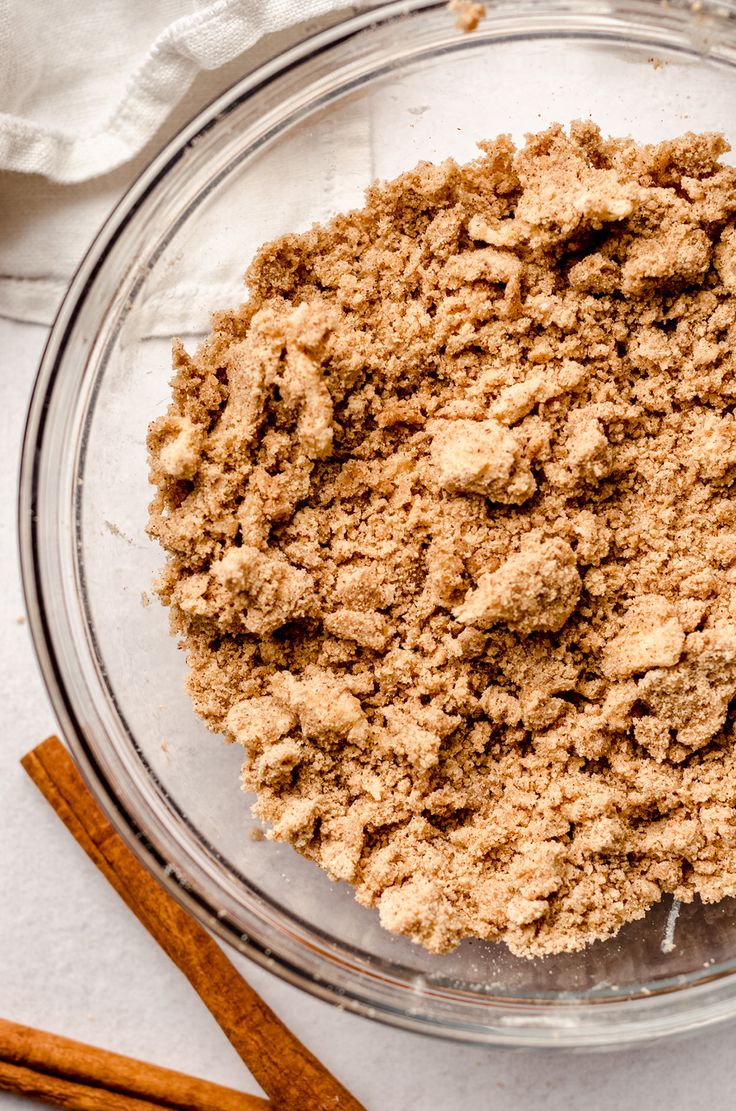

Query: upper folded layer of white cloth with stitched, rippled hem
[{"left": 0, "top": 0, "right": 355, "bottom": 183}]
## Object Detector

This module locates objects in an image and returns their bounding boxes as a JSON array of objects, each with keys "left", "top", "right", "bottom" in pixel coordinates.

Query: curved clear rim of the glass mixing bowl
[{"left": 18, "top": 0, "right": 736, "bottom": 1047}]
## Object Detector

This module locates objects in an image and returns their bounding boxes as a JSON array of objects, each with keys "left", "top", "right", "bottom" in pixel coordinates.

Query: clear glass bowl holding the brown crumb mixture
[{"left": 20, "top": 0, "right": 736, "bottom": 1047}]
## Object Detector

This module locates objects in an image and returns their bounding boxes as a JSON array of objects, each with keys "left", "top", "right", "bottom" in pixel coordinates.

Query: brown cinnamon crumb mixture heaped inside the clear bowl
[{"left": 149, "top": 122, "right": 736, "bottom": 955}]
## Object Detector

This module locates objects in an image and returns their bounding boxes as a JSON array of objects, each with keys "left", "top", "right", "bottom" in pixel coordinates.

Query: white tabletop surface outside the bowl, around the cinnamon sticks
[{"left": 0, "top": 320, "right": 736, "bottom": 1111}]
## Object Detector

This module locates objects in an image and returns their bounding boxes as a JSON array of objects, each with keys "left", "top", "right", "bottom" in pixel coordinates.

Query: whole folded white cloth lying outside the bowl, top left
[{"left": 0, "top": 0, "right": 366, "bottom": 323}]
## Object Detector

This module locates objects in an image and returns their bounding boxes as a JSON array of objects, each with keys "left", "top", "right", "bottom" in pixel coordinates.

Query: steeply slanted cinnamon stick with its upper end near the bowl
[{"left": 21, "top": 737, "right": 365, "bottom": 1111}]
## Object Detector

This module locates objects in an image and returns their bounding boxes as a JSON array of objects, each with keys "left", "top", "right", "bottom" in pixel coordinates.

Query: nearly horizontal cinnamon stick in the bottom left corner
[{"left": 0, "top": 1019, "right": 269, "bottom": 1111}]
